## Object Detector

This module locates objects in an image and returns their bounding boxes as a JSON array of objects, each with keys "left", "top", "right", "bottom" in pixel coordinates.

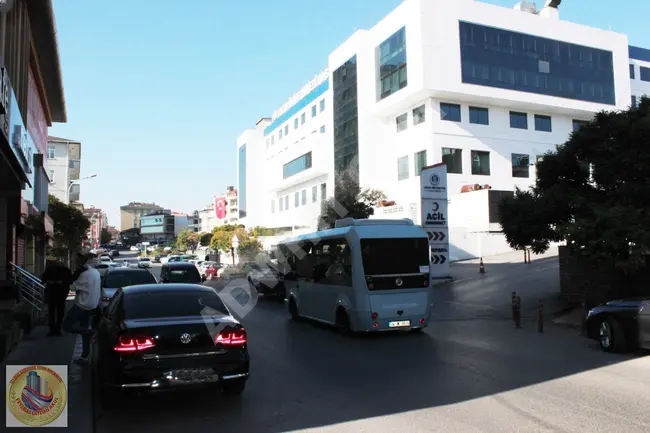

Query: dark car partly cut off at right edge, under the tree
[{"left": 586, "top": 297, "right": 650, "bottom": 352}]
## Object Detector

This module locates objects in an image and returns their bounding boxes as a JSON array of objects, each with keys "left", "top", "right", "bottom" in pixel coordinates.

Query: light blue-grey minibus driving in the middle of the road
[{"left": 276, "top": 218, "right": 431, "bottom": 333}]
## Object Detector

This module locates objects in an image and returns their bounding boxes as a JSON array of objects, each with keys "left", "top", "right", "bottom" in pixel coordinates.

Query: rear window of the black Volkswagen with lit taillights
[{"left": 124, "top": 290, "right": 229, "bottom": 319}]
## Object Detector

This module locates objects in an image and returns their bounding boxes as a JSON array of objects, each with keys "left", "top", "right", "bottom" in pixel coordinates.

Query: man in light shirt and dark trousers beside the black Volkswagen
[{"left": 63, "top": 254, "right": 101, "bottom": 364}]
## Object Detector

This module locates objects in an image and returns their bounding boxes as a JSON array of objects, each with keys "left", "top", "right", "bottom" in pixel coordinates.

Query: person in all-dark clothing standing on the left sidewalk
[{"left": 41, "top": 260, "right": 72, "bottom": 336}]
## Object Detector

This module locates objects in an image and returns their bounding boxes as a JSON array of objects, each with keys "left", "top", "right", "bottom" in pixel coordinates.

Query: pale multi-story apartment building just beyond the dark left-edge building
[{"left": 47, "top": 137, "right": 81, "bottom": 204}]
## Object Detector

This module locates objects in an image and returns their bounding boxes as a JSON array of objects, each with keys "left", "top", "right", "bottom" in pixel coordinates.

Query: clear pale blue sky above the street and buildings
[{"left": 50, "top": 0, "right": 650, "bottom": 227}]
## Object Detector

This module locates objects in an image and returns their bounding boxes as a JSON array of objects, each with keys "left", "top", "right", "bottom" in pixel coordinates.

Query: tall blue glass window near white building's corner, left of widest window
[{"left": 377, "top": 27, "right": 408, "bottom": 100}]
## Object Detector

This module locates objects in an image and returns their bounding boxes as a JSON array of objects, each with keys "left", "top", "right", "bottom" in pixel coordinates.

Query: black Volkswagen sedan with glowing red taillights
[{"left": 94, "top": 284, "right": 250, "bottom": 405}]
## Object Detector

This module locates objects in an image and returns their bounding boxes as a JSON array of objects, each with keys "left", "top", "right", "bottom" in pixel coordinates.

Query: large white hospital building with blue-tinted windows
[{"left": 237, "top": 0, "right": 650, "bottom": 259}]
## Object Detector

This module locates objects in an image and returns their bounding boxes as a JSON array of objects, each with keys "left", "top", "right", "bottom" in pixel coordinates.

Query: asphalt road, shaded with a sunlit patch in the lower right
[{"left": 97, "top": 251, "right": 650, "bottom": 433}]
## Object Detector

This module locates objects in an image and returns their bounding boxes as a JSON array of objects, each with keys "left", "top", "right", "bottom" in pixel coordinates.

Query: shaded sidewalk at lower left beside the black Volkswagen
[{"left": 0, "top": 302, "right": 94, "bottom": 433}]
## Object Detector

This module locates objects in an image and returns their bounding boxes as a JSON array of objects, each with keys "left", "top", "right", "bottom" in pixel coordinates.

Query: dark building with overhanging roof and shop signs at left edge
[{"left": 0, "top": 0, "right": 66, "bottom": 278}]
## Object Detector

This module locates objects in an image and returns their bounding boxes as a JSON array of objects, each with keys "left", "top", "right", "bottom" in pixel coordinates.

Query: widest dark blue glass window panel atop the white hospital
[{"left": 459, "top": 21, "right": 616, "bottom": 105}]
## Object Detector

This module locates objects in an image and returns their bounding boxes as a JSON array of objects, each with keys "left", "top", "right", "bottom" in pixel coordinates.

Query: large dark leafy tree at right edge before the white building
[{"left": 499, "top": 98, "right": 650, "bottom": 274}]
